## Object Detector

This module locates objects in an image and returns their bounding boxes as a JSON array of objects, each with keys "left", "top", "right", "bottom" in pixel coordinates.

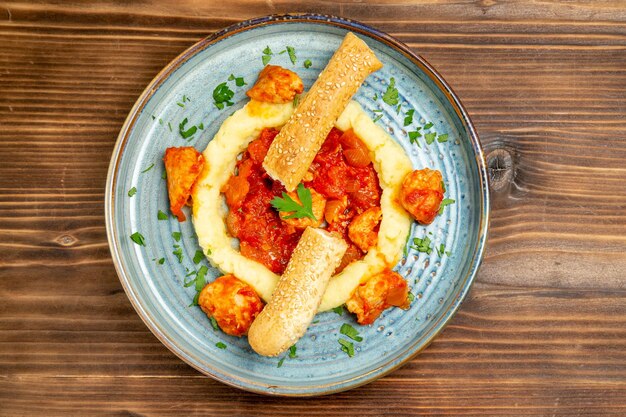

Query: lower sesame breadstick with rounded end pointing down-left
[{"left": 248, "top": 227, "right": 348, "bottom": 356}]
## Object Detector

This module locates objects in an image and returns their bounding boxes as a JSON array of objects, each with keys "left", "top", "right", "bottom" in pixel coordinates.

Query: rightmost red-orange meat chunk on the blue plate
[{"left": 400, "top": 168, "right": 443, "bottom": 224}]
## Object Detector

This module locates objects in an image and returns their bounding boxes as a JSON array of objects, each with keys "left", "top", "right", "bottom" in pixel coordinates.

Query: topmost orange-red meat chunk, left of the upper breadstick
[{"left": 246, "top": 65, "right": 304, "bottom": 103}]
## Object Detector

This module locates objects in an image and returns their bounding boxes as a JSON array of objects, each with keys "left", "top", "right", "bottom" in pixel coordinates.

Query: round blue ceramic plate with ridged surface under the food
[{"left": 106, "top": 15, "right": 489, "bottom": 396}]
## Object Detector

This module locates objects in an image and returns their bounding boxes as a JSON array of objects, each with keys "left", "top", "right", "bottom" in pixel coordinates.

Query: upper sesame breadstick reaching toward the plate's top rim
[{"left": 263, "top": 32, "right": 383, "bottom": 191}]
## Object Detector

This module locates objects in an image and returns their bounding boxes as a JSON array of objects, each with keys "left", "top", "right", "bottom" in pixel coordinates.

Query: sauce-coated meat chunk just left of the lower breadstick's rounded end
[{"left": 198, "top": 275, "right": 264, "bottom": 336}]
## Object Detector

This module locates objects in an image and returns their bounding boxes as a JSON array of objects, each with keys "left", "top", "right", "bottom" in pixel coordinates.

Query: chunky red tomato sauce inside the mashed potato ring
[{"left": 222, "top": 128, "right": 382, "bottom": 274}]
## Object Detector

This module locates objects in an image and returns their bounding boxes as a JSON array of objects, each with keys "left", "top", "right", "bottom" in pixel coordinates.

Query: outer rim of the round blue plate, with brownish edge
[{"left": 105, "top": 13, "right": 490, "bottom": 397}]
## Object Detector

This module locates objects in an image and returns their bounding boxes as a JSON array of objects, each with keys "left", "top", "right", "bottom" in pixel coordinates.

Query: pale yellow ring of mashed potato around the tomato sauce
[{"left": 193, "top": 100, "right": 412, "bottom": 311}]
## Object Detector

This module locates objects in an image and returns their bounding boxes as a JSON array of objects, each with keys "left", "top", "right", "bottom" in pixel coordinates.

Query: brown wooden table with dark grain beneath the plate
[{"left": 0, "top": 0, "right": 626, "bottom": 416}]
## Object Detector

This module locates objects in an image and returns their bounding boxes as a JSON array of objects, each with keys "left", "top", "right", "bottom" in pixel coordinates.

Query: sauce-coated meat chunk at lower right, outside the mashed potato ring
[{"left": 346, "top": 269, "right": 410, "bottom": 325}]
